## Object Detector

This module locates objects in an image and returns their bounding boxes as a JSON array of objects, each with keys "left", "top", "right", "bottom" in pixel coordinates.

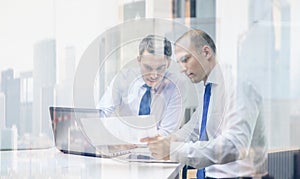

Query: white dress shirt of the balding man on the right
[{"left": 171, "top": 64, "right": 267, "bottom": 178}]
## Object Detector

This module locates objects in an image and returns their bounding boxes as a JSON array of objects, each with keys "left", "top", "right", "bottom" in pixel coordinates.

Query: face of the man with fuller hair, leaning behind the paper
[{"left": 138, "top": 51, "right": 170, "bottom": 87}]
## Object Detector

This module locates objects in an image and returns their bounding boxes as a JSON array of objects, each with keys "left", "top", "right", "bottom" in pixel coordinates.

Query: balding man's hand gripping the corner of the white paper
[{"left": 140, "top": 135, "right": 171, "bottom": 160}]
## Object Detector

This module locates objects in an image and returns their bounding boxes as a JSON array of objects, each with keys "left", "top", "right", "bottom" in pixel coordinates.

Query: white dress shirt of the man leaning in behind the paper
[{"left": 97, "top": 68, "right": 184, "bottom": 136}]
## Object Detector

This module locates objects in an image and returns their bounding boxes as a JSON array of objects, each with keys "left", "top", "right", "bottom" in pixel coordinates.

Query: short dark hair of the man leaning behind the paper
[{"left": 139, "top": 35, "right": 172, "bottom": 58}]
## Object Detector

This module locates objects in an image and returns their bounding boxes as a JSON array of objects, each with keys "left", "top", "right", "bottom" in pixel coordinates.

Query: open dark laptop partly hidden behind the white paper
[{"left": 49, "top": 106, "right": 135, "bottom": 158}]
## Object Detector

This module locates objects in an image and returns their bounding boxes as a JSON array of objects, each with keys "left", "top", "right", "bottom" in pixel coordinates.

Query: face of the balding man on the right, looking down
[{"left": 175, "top": 39, "right": 210, "bottom": 83}]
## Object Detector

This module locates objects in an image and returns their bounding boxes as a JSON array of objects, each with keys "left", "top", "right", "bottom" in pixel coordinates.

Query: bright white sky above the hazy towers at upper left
[{"left": 0, "top": 0, "right": 119, "bottom": 79}]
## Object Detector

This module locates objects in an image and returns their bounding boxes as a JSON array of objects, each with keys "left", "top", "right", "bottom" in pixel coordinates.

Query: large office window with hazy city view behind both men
[{"left": 0, "top": 0, "right": 300, "bottom": 149}]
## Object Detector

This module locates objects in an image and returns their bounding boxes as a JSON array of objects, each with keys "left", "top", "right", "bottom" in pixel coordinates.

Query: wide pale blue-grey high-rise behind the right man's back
[{"left": 237, "top": 1, "right": 291, "bottom": 148}]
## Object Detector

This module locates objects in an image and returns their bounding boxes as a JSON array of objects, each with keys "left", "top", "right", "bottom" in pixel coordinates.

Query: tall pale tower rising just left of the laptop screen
[{"left": 32, "top": 39, "right": 56, "bottom": 138}]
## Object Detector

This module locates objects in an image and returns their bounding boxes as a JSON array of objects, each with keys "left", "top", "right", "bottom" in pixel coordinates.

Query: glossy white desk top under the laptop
[{"left": 0, "top": 148, "right": 182, "bottom": 179}]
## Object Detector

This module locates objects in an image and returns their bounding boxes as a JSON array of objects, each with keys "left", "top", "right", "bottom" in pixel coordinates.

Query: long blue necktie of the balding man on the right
[{"left": 197, "top": 83, "right": 211, "bottom": 179}]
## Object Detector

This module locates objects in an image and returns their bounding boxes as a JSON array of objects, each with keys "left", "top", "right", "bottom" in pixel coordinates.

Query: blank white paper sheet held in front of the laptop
[{"left": 80, "top": 116, "right": 158, "bottom": 146}]
